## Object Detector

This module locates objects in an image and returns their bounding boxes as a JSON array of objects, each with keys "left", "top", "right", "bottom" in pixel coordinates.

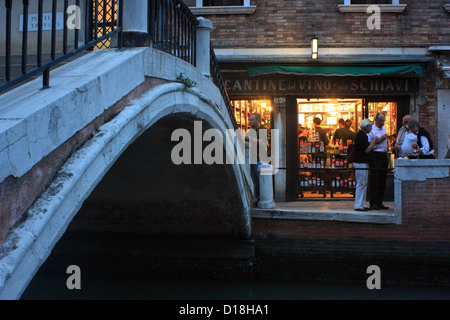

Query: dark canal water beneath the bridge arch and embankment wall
[{"left": 22, "top": 233, "right": 450, "bottom": 301}]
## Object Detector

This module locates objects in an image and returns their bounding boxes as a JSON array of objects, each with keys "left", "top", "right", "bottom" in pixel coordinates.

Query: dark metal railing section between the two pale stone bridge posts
[{"left": 148, "top": 0, "right": 198, "bottom": 66}]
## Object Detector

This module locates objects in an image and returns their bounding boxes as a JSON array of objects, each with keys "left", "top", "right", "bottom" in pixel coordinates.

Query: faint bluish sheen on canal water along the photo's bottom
[{"left": 22, "top": 275, "right": 450, "bottom": 300}]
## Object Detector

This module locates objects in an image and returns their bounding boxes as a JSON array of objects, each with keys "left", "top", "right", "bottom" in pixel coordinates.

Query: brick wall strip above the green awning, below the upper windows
[{"left": 185, "top": 0, "right": 450, "bottom": 47}]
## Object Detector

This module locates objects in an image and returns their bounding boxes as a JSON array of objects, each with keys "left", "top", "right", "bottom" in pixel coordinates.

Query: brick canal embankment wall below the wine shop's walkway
[{"left": 252, "top": 172, "right": 450, "bottom": 287}]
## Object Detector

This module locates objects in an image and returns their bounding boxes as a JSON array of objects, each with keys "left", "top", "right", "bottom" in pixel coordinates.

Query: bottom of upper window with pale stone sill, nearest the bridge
[{"left": 190, "top": 0, "right": 256, "bottom": 15}]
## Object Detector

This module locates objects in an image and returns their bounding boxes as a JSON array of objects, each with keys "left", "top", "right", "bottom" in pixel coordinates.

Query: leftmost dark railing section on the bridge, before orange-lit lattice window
[{"left": 0, "top": 0, "right": 123, "bottom": 93}]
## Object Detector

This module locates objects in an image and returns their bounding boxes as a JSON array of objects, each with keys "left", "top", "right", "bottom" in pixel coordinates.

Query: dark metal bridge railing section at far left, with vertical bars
[{"left": 0, "top": 0, "right": 123, "bottom": 93}]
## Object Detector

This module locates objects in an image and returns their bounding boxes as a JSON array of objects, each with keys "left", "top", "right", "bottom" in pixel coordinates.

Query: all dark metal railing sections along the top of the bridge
[{"left": 0, "top": 0, "right": 237, "bottom": 128}]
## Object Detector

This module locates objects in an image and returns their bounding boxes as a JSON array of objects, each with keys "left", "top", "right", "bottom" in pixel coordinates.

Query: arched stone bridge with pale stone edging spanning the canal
[{"left": 0, "top": 40, "right": 252, "bottom": 299}]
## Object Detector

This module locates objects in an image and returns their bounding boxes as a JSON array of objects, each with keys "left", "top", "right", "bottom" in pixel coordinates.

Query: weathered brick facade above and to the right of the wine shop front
[{"left": 184, "top": 0, "right": 450, "bottom": 152}]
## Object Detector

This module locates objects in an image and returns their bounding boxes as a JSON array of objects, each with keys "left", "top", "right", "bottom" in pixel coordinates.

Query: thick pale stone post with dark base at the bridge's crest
[{"left": 122, "top": 0, "right": 151, "bottom": 47}]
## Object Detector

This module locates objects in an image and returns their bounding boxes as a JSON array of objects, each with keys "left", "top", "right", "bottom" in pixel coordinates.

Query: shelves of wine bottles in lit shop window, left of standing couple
[{"left": 298, "top": 135, "right": 356, "bottom": 197}]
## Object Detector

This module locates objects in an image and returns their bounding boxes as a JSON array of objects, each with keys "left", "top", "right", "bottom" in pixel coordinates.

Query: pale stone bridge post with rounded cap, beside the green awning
[{"left": 196, "top": 17, "right": 212, "bottom": 78}]
